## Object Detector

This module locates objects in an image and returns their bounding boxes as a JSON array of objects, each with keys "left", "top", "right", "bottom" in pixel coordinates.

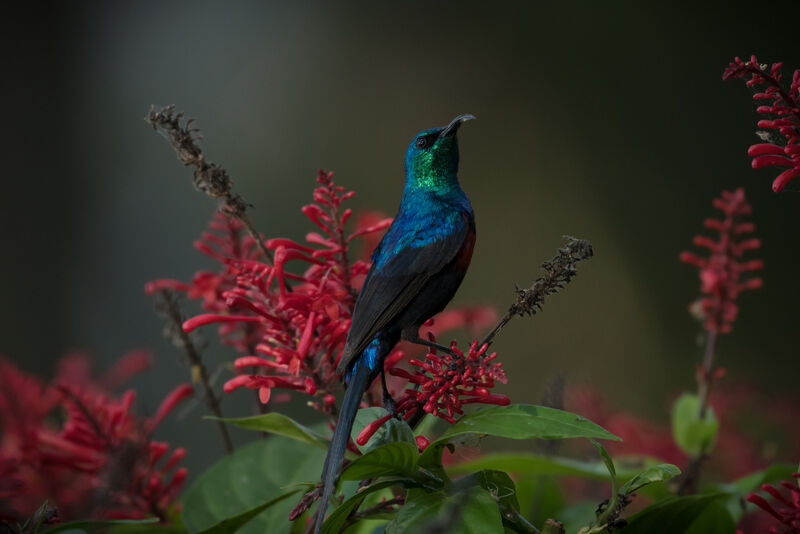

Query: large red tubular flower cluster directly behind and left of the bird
[{"left": 146, "top": 171, "right": 494, "bottom": 413}]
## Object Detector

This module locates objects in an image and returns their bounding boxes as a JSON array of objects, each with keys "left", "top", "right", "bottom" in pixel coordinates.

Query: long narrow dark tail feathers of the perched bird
[{"left": 314, "top": 365, "right": 374, "bottom": 534}]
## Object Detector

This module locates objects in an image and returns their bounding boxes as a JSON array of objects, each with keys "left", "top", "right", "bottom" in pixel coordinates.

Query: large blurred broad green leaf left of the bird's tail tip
[{"left": 182, "top": 436, "right": 325, "bottom": 534}]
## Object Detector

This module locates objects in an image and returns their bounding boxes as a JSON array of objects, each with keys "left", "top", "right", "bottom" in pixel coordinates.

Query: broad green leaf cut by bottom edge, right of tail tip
[{"left": 386, "top": 486, "right": 503, "bottom": 534}]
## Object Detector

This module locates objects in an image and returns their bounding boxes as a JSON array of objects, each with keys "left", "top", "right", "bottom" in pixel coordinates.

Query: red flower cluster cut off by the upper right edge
[{"left": 722, "top": 56, "right": 800, "bottom": 192}]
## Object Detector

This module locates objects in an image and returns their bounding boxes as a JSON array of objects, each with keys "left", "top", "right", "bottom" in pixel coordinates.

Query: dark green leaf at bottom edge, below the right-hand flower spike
[{"left": 620, "top": 493, "right": 734, "bottom": 534}]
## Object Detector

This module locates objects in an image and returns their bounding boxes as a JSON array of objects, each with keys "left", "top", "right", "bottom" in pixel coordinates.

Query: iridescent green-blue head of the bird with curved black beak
[{"left": 406, "top": 114, "right": 475, "bottom": 189}]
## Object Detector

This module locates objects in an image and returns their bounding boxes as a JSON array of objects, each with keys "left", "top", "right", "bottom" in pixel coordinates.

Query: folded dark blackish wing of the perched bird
[{"left": 337, "top": 220, "right": 470, "bottom": 373}]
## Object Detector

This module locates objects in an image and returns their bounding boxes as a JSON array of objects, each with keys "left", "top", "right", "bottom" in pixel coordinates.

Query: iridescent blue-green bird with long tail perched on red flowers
[{"left": 314, "top": 114, "right": 475, "bottom": 534}]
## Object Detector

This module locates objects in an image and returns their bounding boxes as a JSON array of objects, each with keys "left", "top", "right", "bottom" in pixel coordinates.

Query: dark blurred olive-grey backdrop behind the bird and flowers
[{"left": 0, "top": 1, "right": 800, "bottom": 480}]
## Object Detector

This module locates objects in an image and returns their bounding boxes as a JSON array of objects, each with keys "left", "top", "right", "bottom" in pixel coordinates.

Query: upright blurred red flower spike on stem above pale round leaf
[{"left": 680, "top": 188, "right": 764, "bottom": 334}]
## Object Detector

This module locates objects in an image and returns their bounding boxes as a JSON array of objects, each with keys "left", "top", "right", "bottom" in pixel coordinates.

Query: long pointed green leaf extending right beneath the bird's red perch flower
[{"left": 420, "top": 404, "right": 620, "bottom": 474}]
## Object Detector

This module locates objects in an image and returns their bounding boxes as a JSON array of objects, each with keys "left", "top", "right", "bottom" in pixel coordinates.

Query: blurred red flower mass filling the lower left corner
[{"left": 0, "top": 352, "right": 192, "bottom": 520}]
